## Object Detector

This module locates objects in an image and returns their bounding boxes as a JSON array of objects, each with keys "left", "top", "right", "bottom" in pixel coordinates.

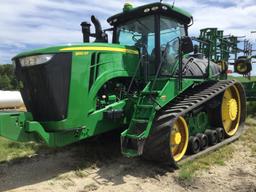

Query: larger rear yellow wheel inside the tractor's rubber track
[{"left": 221, "top": 86, "right": 241, "bottom": 136}]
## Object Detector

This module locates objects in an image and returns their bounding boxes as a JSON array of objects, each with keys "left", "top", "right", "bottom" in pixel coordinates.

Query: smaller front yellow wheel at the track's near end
[{"left": 170, "top": 117, "right": 189, "bottom": 161}]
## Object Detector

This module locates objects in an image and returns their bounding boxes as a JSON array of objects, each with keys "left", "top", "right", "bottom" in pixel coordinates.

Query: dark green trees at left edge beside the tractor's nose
[{"left": 0, "top": 64, "right": 20, "bottom": 90}]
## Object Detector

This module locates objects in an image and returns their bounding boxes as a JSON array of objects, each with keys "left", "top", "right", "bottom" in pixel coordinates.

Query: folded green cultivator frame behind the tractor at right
[{"left": 198, "top": 28, "right": 256, "bottom": 101}]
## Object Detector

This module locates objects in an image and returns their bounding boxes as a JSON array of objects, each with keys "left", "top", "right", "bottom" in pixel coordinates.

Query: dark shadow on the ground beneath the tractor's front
[{"left": 0, "top": 130, "right": 172, "bottom": 191}]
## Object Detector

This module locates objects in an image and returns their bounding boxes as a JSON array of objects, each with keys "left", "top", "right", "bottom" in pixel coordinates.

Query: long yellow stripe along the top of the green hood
[{"left": 60, "top": 47, "right": 139, "bottom": 55}]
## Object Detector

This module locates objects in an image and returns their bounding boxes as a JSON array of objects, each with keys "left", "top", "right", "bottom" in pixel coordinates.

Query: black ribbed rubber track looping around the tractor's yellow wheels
[{"left": 143, "top": 80, "right": 245, "bottom": 167}]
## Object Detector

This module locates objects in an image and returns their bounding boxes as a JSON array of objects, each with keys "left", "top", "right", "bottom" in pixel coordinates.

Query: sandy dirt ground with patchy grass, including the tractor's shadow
[{"left": 0, "top": 122, "right": 256, "bottom": 192}]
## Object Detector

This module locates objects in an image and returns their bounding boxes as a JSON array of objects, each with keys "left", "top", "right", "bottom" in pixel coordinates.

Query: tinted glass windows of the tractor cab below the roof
[{"left": 115, "top": 15, "right": 185, "bottom": 76}]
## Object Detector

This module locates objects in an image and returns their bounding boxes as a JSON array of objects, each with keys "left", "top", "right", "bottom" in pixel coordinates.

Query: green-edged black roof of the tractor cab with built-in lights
[{"left": 107, "top": 2, "right": 193, "bottom": 26}]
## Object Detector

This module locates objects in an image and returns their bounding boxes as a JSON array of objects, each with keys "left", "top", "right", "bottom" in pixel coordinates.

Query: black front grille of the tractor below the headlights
[{"left": 16, "top": 53, "right": 72, "bottom": 122}]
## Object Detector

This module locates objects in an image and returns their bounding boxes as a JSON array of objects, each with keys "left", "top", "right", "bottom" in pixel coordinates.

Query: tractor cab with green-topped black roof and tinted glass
[{"left": 108, "top": 3, "right": 193, "bottom": 78}]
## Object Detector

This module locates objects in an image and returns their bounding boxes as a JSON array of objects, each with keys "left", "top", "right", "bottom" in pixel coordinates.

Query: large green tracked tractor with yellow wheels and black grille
[{"left": 0, "top": 2, "right": 246, "bottom": 167}]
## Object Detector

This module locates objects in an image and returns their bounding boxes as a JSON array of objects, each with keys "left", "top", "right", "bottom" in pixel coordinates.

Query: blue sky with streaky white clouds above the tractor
[{"left": 0, "top": 0, "right": 256, "bottom": 73}]
